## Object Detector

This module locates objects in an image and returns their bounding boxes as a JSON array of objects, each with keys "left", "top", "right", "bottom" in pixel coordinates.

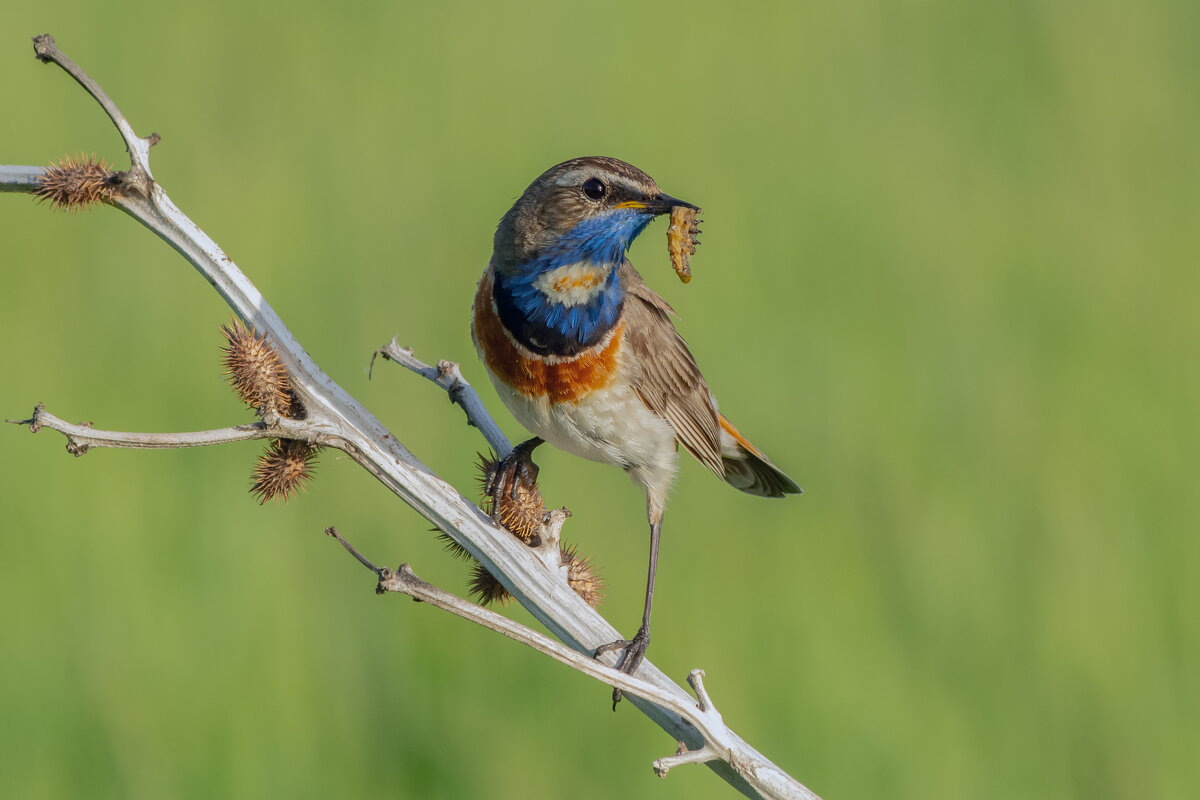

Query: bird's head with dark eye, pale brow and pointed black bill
[{"left": 493, "top": 156, "right": 695, "bottom": 273}]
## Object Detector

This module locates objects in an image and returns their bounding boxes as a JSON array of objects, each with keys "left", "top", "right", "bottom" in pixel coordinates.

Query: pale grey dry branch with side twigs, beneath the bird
[{"left": 0, "top": 35, "right": 816, "bottom": 800}]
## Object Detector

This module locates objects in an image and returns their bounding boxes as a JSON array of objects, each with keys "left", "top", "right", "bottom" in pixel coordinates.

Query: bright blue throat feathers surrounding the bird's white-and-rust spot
[{"left": 493, "top": 209, "right": 653, "bottom": 355}]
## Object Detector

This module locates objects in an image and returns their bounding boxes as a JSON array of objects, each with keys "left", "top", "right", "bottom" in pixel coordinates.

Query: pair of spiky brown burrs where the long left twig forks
[{"left": 221, "top": 321, "right": 320, "bottom": 503}]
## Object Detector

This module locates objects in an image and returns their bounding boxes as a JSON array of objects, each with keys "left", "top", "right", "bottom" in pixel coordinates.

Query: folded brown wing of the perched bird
[{"left": 620, "top": 261, "right": 725, "bottom": 479}]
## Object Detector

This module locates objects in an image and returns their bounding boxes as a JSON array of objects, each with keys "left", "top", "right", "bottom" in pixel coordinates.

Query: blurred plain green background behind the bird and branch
[{"left": 0, "top": 0, "right": 1200, "bottom": 800}]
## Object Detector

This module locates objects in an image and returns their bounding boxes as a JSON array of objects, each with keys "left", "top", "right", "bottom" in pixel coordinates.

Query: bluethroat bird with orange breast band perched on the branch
[{"left": 472, "top": 157, "right": 800, "bottom": 705}]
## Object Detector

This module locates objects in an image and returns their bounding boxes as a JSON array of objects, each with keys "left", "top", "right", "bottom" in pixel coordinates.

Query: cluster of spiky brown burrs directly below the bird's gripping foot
[{"left": 442, "top": 445, "right": 604, "bottom": 608}]
